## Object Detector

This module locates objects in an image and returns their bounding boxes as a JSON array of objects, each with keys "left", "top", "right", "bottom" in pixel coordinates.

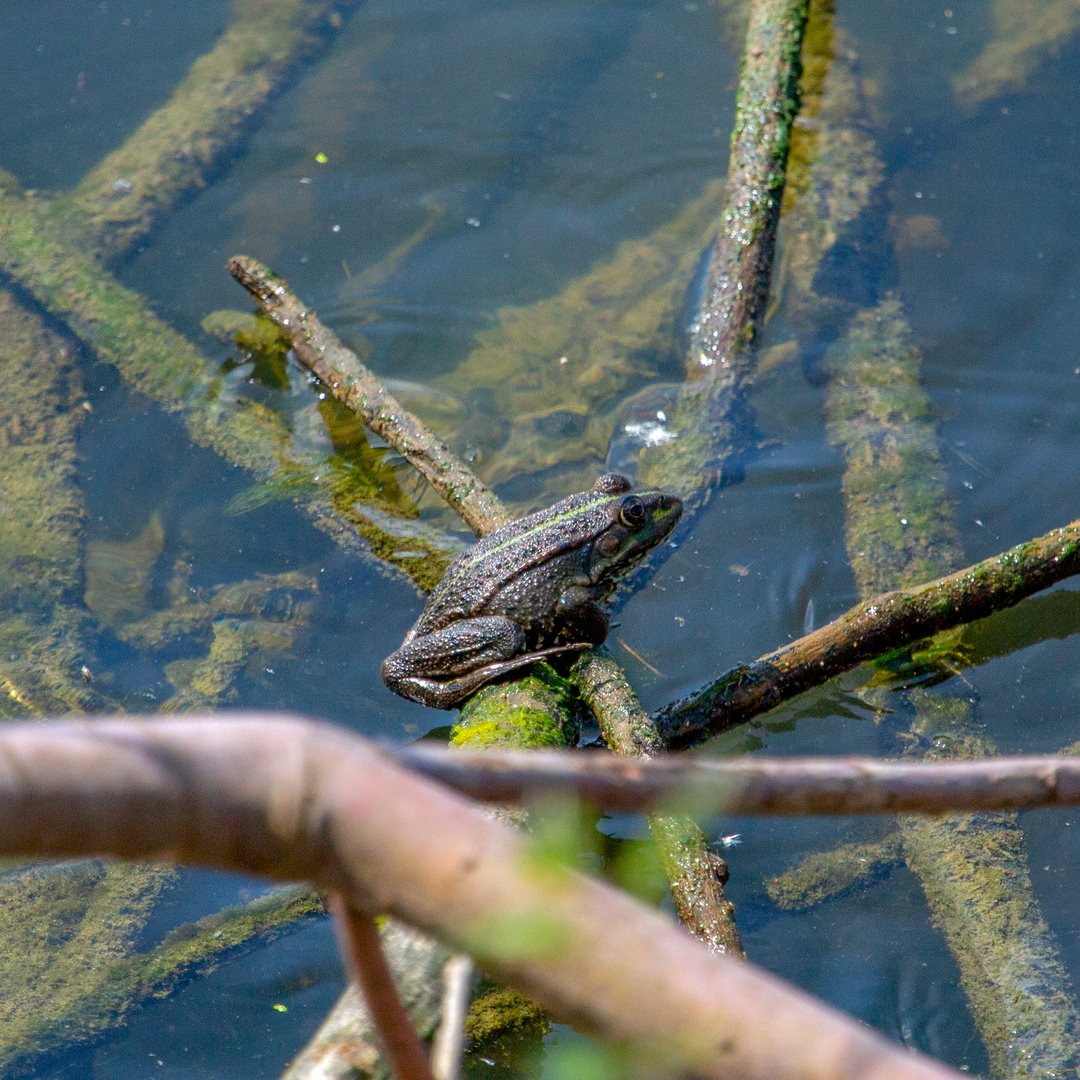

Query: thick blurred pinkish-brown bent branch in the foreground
[{"left": 0, "top": 716, "right": 959, "bottom": 1080}]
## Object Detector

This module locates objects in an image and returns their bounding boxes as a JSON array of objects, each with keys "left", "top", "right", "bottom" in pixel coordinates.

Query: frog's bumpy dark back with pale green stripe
[{"left": 414, "top": 491, "right": 618, "bottom": 634}]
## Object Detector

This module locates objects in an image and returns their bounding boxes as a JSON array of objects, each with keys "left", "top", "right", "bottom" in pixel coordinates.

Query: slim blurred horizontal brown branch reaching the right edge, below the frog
[{"left": 395, "top": 745, "right": 1080, "bottom": 818}]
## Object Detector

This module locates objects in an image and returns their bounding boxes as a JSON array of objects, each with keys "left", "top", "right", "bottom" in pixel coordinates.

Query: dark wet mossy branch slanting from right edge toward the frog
[{"left": 653, "top": 521, "right": 1080, "bottom": 750}]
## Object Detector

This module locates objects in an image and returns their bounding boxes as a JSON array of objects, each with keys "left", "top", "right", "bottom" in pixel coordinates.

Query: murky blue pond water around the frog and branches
[{"left": 0, "top": 0, "right": 1080, "bottom": 1080}]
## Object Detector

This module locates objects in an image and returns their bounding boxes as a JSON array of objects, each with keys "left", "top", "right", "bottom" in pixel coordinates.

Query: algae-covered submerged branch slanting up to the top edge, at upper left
[{"left": 69, "top": 0, "right": 367, "bottom": 258}]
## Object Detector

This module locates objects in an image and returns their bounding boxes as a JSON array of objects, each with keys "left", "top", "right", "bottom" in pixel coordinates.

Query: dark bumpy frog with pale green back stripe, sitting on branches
[{"left": 382, "top": 473, "right": 683, "bottom": 708}]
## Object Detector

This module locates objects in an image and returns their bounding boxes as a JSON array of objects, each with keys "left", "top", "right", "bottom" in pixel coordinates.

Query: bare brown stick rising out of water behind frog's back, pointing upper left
[{"left": 229, "top": 255, "right": 509, "bottom": 537}]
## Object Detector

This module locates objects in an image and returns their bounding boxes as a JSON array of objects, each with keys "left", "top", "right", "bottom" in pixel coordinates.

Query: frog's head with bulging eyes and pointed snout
[{"left": 589, "top": 474, "right": 683, "bottom": 584}]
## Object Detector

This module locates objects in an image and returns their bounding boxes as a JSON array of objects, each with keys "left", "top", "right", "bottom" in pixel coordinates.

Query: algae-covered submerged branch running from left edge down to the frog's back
[{"left": 0, "top": 174, "right": 448, "bottom": 600}]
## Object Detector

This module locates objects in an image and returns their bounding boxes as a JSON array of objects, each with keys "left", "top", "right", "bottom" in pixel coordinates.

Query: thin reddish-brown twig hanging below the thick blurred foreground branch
[{"left": 326, "top": 892, "right": 434, "bottom": 1080}]
